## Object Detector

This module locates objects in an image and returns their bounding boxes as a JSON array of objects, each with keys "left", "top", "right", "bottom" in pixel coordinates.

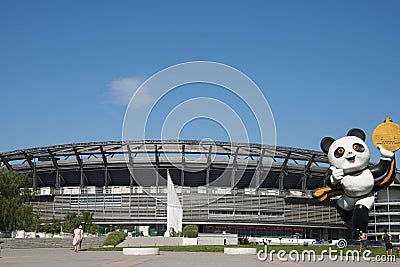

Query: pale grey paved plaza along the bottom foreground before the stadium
[{"left": 0, "top": 248, "right": 398, "bottom": 267}]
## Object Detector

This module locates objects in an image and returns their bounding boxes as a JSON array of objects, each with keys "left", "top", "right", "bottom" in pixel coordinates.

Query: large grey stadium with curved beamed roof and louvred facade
[{"left": 0, "top": 141, "right": 400, "bottom": 241}]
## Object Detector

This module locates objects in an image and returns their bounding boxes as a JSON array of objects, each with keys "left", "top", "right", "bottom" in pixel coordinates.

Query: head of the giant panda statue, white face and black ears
[{"left": 321, "top": 129, "right": 370, "bottom": 173}]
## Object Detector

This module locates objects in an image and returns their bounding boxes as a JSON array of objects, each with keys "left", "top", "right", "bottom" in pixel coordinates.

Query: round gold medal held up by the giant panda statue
[{"left": 372, "top": 117, "right": 400, "bottom": 152}]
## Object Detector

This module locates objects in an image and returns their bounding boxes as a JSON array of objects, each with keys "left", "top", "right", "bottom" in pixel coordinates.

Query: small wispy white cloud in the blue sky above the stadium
[{"left": 110, "top": 77, "right": 152, "bottom": 106}]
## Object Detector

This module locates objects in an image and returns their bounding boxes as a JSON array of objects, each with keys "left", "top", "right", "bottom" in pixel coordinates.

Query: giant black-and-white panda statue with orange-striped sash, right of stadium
[{"left": 313, "top": 129, "right": 396, "bottom": 237}]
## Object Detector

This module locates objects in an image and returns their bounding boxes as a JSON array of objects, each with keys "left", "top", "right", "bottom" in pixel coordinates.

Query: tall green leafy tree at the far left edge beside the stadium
[{"left": 0, "top": 169, "right": 36, "bottom": 231}]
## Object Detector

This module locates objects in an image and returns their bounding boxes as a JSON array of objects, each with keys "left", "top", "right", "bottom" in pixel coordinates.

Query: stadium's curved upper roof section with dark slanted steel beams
[{"left": 0, "top": 141, "right": 396, "bottom": 192}]
